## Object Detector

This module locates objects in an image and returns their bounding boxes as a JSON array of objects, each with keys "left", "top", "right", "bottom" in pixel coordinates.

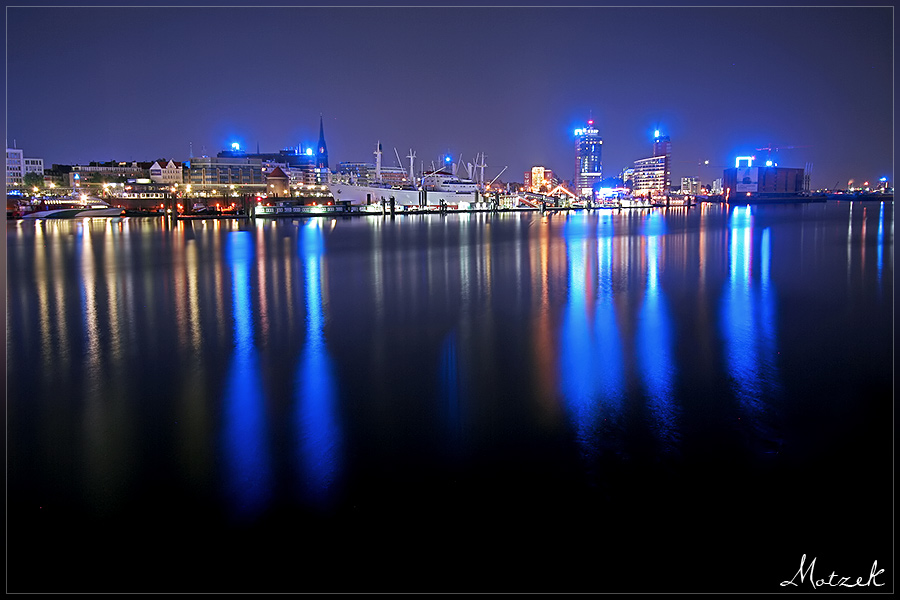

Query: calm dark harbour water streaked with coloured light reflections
[{"left": 6, "top": 202, "right": 894, "bottom": 592}]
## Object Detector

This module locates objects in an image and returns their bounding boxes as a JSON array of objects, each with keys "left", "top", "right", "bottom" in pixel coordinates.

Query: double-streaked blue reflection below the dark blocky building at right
[{"left": 720, "top": 206, "right": 778, "bottom": 450}]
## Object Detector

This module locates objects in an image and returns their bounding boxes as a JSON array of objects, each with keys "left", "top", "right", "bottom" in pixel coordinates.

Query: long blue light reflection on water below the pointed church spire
[{"left": 295, "top": 219, "right": 341, "bottom": 503}]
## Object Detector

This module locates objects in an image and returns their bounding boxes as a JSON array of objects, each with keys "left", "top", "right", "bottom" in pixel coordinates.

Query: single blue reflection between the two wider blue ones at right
[{"left": 636, "top": 211, "right": 678, "bottom": 451}]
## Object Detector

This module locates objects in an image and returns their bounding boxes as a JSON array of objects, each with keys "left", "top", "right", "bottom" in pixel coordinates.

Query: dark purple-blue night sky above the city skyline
[{"left": 6, "top": 6, "right": 894, "bottom": 188}]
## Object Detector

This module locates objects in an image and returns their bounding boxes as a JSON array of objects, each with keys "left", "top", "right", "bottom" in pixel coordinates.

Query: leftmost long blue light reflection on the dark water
[{"left": 223, "top": 231, "right": 272, "bottom": 518}]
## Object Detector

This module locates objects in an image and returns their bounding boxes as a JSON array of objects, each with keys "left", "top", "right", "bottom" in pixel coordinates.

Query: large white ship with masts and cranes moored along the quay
[{"left": 326, "top": 142, "right": 506, "bottom": 211}]
